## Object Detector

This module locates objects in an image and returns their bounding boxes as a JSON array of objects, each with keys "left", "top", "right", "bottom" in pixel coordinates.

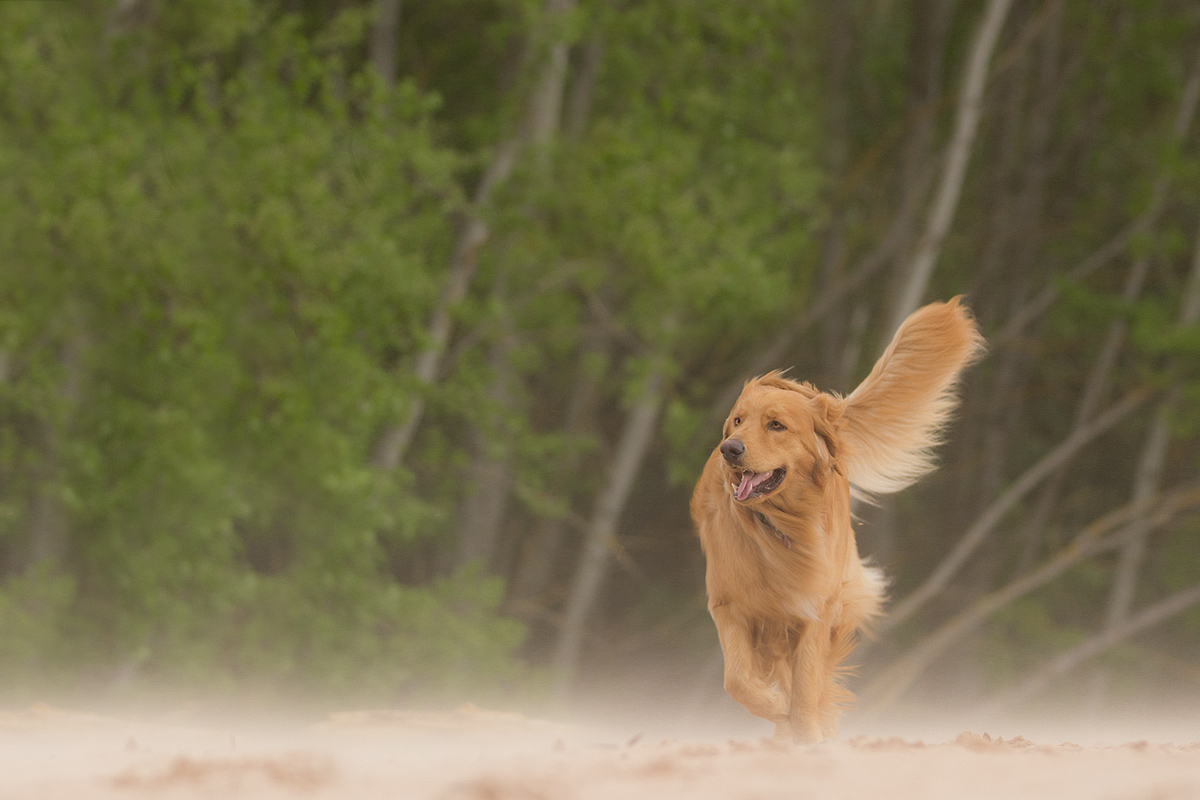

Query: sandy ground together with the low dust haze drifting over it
[{"left": 0, "top": 675, "right": 1200, "bottom": 800}]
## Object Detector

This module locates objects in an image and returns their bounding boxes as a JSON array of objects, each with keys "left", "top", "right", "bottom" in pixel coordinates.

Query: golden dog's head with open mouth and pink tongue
[{"left": 718, "top": 372, "right": 840, "bottom": 504}]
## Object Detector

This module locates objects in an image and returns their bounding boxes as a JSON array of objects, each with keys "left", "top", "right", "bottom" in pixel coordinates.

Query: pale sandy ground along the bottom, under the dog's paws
[{"left": 7, "top": 706, "right": 1200, "bottom": 800}]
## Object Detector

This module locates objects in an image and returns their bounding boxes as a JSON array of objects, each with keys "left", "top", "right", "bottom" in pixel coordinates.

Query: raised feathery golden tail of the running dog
[{"left": 840, "top": 297, "right": 984, "bottom": 494}]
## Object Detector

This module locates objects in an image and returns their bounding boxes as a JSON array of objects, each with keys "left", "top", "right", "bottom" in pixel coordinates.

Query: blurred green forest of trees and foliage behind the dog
[{"left": 0, "top": 0, "right": 1200, "bottom": 708}]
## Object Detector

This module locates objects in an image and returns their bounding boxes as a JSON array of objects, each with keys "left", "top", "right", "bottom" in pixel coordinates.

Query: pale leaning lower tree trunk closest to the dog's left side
[{"left": 554, "top": 368, "right": 664, "bottom": 697}]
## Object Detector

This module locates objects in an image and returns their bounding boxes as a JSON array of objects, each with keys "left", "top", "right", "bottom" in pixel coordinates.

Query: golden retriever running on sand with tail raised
[{"left": 691, "top": 297, "right": 983, "bottom": 741}]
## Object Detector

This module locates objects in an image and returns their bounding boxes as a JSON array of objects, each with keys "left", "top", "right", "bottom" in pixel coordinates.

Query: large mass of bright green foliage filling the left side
[{"left": 0, "top": 2, "right": 522, "bottom": 696}]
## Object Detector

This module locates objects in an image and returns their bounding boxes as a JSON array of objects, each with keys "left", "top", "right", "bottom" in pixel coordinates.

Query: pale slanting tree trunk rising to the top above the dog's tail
[{"left": 884, "top": 0, "right": 1012, "bottom": 339}]
